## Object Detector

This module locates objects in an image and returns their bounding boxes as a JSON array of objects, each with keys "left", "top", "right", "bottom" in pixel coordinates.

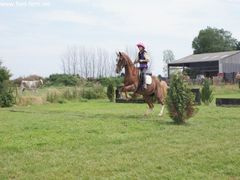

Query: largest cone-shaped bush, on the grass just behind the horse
[{"left": 166, "top": 74, "right": 196, "bottom": 124}]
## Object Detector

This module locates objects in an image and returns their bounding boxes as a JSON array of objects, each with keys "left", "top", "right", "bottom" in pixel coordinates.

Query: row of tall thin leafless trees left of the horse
[{"left": 61, "top": 46, "right": 116, "bottom": 78}]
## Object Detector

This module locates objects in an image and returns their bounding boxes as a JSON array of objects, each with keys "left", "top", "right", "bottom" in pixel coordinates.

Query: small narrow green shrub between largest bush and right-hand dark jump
[{"left": 201, "top": 79, "right": 213, "bottom": 105}]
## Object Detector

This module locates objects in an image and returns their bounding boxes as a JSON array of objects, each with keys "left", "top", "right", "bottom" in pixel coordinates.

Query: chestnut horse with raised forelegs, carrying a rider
[{"left": 116, "top": 52, "right": 168, "bottom": 116}]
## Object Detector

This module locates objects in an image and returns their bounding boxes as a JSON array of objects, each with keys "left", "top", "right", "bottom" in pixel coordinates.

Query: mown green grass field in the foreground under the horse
[{"left": 0, "top": 85, "right": 240, "bottom": 179}]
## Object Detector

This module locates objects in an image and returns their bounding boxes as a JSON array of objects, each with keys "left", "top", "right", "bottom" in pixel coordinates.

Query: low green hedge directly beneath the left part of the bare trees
[{"left": 47, "top": 74, "right": 81, "bottom": 86}]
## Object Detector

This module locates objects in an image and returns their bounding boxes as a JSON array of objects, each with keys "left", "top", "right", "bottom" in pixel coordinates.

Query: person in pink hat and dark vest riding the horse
[{"left": 134, "top": 43, "right": 149, "bottom": 89}]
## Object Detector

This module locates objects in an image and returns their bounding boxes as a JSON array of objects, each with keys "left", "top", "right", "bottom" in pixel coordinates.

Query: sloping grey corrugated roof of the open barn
[{"left": 169, "top": 51, "right": 240, "bottom": 64}]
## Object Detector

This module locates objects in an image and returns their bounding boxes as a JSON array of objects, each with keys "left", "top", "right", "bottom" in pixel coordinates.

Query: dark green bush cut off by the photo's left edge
[{"left": 0, "top": 62, "right": 15, "bottom": 107}]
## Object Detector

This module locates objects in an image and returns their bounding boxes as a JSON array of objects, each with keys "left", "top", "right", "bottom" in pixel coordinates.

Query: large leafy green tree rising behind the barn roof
[{"left": 192, "top": 27, "right": 238, "bottom": 54}]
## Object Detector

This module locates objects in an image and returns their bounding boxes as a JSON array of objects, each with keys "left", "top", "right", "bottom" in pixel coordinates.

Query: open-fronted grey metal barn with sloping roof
[{"left": 168, "top": 51, "right": 240, "bottom": 78}]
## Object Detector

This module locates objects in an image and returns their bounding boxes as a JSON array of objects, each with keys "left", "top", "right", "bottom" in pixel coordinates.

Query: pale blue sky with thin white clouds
[{"left": 0, "top": 0, "right": 240, "bottom": 78}]
